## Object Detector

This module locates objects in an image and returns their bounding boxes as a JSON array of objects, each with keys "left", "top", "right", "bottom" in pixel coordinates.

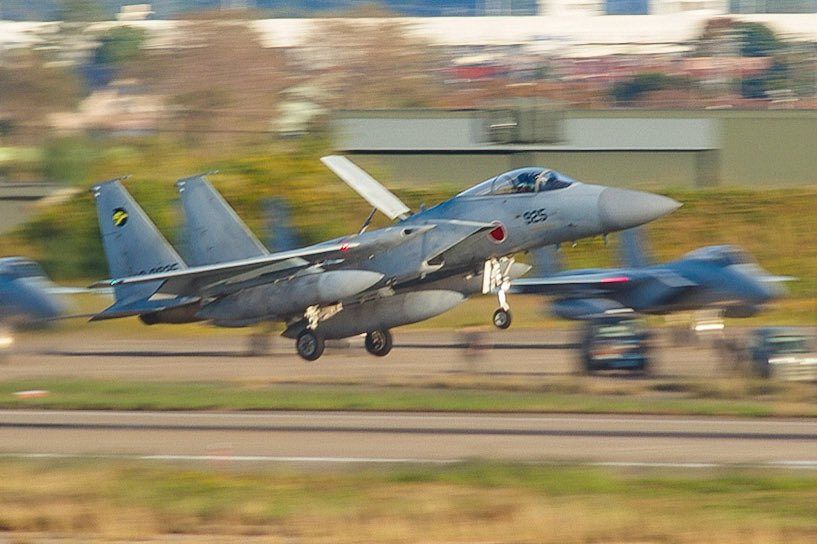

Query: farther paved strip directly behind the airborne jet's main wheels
[{"left": 0, "top": 327, "right": 724, "bottom": 384}]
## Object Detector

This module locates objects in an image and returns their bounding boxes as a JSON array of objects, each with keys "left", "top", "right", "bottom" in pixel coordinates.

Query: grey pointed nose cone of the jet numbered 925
[{"left": 599, "top": 187, "right": 681, "bottom": 232}]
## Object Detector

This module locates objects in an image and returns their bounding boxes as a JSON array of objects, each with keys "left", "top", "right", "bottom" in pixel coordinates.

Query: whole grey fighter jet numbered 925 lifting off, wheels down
[{"left": 92, "top": 156, "right": 680, "bottom": 360}]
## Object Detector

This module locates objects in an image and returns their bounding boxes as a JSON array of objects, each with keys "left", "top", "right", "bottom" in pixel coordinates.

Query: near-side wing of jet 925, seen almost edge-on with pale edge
[{"left": 91, "top": 241, "right": 360, "bottom": 296}]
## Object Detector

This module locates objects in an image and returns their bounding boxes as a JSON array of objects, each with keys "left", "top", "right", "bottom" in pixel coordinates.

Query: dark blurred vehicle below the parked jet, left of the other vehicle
[{"left": 580, "top": 315, "right": 650, "bottom": 372}]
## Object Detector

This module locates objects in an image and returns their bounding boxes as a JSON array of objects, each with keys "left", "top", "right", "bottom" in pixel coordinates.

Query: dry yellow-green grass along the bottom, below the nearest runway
[{"left": 0, "top": 461, "right": 817, "bottom": 544}]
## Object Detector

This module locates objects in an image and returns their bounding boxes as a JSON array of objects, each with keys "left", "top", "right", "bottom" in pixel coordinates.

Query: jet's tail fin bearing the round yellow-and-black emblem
[{"left": 91, "top": 178, "right": 187, "bottom": 303}]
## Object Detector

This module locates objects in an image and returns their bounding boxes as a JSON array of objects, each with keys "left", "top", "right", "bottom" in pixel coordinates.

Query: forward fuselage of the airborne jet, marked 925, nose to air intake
[{"left": 332, "top": 172, "right": 678, "bottom": 294}]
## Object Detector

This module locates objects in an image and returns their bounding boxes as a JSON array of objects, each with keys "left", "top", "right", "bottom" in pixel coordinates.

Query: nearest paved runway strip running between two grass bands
[{"left": 0, "top": 411, "right": 817, "bottom": 469}]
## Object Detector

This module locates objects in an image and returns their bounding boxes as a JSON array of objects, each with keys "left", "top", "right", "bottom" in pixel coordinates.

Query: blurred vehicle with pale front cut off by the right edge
[{"left": 749, "top": 327, "right": 817, "bottom": 380}]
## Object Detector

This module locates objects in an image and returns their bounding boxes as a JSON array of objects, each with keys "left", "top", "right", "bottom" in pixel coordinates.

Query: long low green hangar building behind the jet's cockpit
[{"left": 333, "top": 110, "right": 817, "bottom": 188}]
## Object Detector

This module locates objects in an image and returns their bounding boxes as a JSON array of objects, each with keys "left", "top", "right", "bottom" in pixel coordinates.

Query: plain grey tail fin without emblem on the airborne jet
[{"left": 176, "top": 176, "right": 269, "bottom": 266}]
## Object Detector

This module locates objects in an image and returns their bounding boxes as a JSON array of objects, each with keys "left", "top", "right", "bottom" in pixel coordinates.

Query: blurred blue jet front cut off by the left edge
[{"left": 0, "top": 257, "right": 65, "bottom": 327}]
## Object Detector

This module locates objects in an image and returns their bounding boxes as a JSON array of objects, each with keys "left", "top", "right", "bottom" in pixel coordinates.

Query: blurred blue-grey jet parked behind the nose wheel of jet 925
[{"left": 511, "top": 229, "right": 790, "bottom": 319}]
